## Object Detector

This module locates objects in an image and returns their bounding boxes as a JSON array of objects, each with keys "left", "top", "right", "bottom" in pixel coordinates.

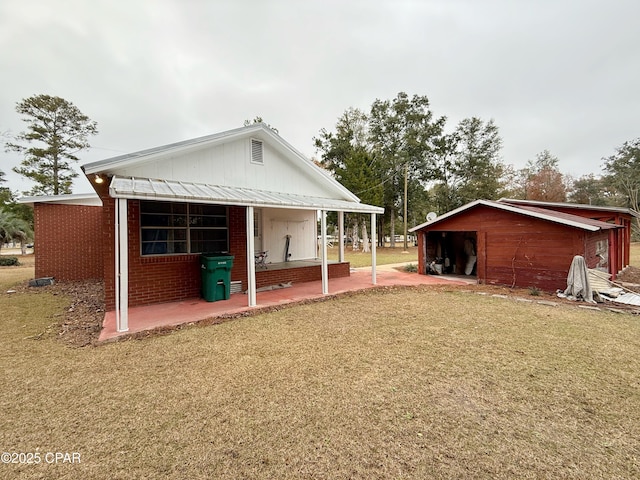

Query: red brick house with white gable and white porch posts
[{"left": 22, "top": 124, "right": 384, "bottom": 331}]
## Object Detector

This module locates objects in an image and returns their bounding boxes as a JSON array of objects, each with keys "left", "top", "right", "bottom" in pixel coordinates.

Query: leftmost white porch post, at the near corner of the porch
[{"left": 115, "top": 198, "right": 129, "bottom": 332}]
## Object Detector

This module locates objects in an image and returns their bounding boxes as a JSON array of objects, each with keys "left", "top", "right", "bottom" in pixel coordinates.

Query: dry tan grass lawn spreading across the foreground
[{"left": 0, "top": 254, "right": 640, "bottom": 479}]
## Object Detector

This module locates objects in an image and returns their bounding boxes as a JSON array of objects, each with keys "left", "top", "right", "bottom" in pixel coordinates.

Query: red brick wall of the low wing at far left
[{"left": 34, "top": 203, "right": 103, "bottom": 281}]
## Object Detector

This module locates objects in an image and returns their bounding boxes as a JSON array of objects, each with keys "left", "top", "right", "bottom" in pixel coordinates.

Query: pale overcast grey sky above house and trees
[{"left": 0, "top": 0, "right": 640, "bottom": 193}]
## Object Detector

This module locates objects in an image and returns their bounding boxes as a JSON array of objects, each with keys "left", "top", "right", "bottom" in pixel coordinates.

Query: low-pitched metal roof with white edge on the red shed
[{"left": 409, "top": 200, "right": 620, "bottom": 232}]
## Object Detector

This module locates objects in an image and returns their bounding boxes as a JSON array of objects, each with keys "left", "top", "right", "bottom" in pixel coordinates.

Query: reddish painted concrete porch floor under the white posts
[{"left": 99, "top": 262, "right": 475, "bottom": 342}]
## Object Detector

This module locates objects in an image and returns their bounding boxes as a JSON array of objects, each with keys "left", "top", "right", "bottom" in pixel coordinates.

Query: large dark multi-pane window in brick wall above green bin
[{"left": 140, "top": 200, "right": 229, "bottom": 255}]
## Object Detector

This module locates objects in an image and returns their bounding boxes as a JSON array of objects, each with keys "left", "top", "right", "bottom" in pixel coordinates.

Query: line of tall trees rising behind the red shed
[{"left": 314, "top": 92, "right": 640, "bottom": 246}]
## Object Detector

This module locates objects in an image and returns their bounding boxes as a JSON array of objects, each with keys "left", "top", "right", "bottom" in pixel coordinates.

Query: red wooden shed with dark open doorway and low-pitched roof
[{"left": 411, "top": 199, "right": 638, "bottom": 291}]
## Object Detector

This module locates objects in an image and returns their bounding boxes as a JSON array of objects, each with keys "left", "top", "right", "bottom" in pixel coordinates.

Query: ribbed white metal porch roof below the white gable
[{"left": 109, "top": 175, "right": 384, "bottom": 214}]
